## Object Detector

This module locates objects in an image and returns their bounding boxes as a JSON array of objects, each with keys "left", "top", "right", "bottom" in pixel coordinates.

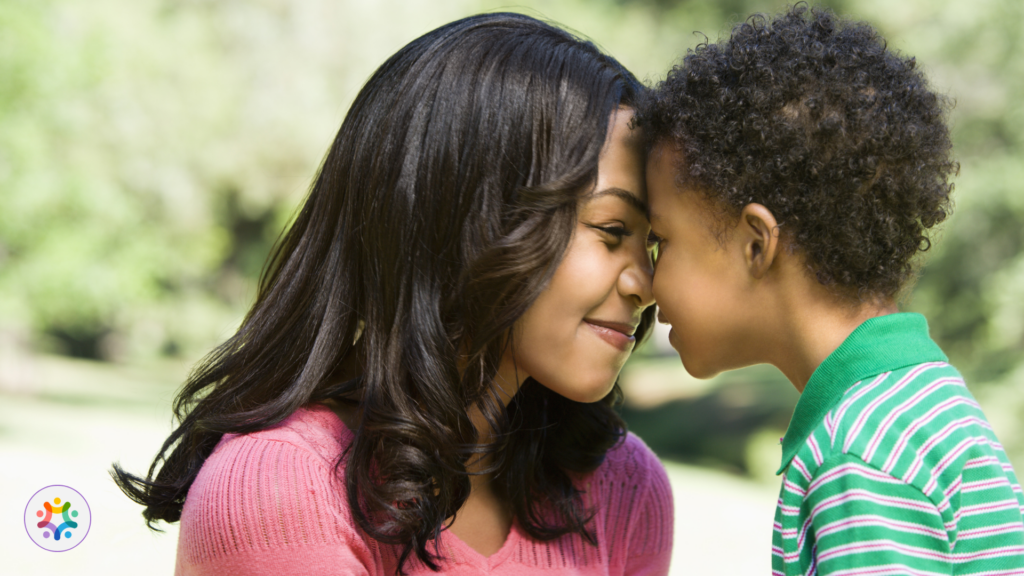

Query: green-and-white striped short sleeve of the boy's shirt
[{"left": 798, "top": 454, "right": 952, "bottom": 576}]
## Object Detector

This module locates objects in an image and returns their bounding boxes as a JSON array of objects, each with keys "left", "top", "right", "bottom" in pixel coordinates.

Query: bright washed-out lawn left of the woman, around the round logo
[{"left": 0, "top": 357, "right": 185, "bottom": 576}]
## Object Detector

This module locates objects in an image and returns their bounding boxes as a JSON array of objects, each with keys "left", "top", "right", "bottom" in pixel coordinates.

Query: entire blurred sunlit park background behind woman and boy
[{"left": 0, "top": 0, "right": 1024, "bottom": 574}]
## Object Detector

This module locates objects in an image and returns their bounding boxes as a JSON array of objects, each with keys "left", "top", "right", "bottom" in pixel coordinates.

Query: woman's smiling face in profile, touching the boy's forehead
[{"left": 502, "top": 108, "right": 654, "bottom": 402}]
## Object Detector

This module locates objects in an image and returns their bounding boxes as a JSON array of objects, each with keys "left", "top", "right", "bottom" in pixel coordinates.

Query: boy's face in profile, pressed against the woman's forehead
[{"left": 647, "top": 145, "right": 754, "bottom": 378}]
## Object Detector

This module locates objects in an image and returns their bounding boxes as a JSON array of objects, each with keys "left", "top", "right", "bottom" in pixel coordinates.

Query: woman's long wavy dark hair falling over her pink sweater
[{"left": 113, "top": 13, "right": 653, "bottom": 570}]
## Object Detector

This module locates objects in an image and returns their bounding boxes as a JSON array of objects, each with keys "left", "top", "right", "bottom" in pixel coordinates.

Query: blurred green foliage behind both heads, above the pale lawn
[{"left": 0, "top": 0, "right": 1024, "bottom": 381}]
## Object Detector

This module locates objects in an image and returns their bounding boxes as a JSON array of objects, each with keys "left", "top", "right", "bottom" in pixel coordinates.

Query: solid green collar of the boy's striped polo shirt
[{"left": 775, "top": 313, "right": 948, "bottom": 474}]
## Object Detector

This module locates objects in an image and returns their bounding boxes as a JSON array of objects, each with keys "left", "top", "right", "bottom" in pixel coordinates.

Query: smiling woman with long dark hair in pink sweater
[{"left": 115, "top": 14, "right": 672, "bottom": 575}]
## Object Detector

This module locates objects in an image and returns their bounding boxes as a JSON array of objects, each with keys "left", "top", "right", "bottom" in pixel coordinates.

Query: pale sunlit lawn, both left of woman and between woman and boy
[{"left": 0, "top": 357, "right": 777, "bottom": 576}]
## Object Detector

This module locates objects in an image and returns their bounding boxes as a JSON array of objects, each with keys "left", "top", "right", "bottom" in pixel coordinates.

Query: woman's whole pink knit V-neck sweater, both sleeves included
[{"left": 175, "top": 405, "right": 673, "bottom": 576}]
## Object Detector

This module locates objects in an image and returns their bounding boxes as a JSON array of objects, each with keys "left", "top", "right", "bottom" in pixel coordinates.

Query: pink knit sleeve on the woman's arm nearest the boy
[{"left": 612, "top": 440, "right": 675, "bottom": 576}]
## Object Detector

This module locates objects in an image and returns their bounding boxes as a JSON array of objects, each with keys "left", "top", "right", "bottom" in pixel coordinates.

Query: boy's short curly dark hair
[{"left": 637, "top": 3, "right": 958, "bottom": 299}]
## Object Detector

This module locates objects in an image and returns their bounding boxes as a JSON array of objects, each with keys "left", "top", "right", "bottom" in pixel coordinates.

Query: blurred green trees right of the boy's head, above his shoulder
[{"left": 907, "top": 0, "right": 1024, "bottom": 380}]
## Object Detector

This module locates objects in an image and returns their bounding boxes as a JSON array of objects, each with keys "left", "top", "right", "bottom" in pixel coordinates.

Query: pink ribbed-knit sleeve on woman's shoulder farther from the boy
[{"left": 175, "top": 437, "right": 374, "bottom": 576}]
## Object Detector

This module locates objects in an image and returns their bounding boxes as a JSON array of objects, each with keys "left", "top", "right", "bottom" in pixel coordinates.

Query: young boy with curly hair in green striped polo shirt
[{"left": 638, "top": 5, "right": 1024, "bottom": 575}]
